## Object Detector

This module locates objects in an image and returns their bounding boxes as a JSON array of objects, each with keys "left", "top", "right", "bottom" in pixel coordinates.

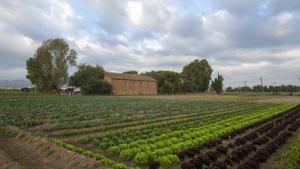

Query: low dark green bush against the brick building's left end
[{"left": 81, "top": 79, "right": 112, "bottom": 95}]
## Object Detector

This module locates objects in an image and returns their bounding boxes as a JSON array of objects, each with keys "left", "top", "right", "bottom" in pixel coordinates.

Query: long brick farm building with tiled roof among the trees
[{"left": 104, "top": 72, "right": 157, "bottom": 95}]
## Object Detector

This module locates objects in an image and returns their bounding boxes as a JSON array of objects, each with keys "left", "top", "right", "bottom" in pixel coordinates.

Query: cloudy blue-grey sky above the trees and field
[{"left": 0, "top": 0, "right": 300, "bottom": 86}]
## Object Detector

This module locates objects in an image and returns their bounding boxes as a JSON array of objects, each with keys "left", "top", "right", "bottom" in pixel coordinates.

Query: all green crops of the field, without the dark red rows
[{"left": 0, "top": 95, "right": 294, "bottom": 168}]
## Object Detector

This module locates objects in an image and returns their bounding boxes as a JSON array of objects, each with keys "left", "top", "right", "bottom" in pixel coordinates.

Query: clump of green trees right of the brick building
[{"left": 142, "top": 59, "right": 223, "bottom": 94}]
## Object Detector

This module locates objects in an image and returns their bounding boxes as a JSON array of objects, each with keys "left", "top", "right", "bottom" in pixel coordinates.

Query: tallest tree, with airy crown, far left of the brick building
[{"left": 26, "top": 39, "right": 77, "bottom": 91}]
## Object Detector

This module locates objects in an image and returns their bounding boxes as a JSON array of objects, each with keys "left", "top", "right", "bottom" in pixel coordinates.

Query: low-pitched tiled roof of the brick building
[{"left": 105, "top": 72, "right": 156, "bottom": 82}]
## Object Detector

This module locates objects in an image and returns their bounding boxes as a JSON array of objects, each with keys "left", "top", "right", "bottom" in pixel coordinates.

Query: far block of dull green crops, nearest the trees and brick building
[{"left": 0, "top": 95, "right": 255, "bottom": 129}]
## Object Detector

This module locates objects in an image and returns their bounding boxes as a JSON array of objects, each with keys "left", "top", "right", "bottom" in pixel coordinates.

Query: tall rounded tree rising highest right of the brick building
[{"left": 182, "top": 59, "right": 213, "bottom": 92}]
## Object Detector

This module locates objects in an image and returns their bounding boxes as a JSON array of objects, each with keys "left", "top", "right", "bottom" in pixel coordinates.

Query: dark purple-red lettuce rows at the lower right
[{"left": 178, "top": 104, "right": 300, "bottom": 169}]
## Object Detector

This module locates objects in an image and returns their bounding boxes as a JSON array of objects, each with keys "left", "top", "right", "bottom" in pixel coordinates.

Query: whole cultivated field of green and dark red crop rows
[{"left": 0, "top": 93, "right": 300, "bottom": 169}]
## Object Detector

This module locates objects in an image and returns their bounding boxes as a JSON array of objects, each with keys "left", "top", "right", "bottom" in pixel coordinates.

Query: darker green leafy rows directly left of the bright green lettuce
[{"left": 81, "top": 104, "right": 274, "bottom": 149}]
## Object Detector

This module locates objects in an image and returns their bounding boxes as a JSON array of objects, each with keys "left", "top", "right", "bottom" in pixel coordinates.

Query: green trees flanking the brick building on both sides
[{"left": 26, "top": 39, "right": 223, "bottom": 94}]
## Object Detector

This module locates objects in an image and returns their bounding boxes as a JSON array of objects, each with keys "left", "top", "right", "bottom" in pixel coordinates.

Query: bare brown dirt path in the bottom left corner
[{"left": 0, "top": 126, "right": 105, "bottom": 169}]
